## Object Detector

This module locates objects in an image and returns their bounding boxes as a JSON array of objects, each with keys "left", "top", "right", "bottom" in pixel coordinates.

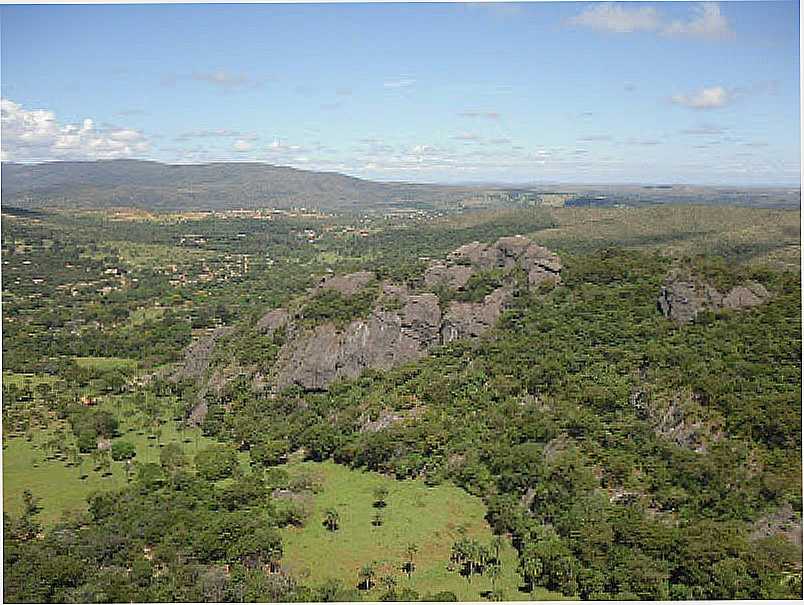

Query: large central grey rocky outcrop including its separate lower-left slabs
[{"left": 179, "top": 236, "right": 561, "bottom": 394}]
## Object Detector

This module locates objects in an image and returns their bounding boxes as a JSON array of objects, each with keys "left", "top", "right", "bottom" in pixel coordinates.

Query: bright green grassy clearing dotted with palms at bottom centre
[{"left": 283, "top": 462, "right": 561, "bottom": 601}]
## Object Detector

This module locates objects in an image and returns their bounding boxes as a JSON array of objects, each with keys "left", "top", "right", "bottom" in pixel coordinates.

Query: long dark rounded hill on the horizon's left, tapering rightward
[{"left": 2, "top": 160, "right": 479, "bottom": 210}]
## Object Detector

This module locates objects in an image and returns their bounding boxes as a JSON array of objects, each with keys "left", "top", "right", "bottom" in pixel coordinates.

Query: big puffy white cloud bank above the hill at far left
[{"left": 0, "top": 99, "right": 150, "bottom": 162}]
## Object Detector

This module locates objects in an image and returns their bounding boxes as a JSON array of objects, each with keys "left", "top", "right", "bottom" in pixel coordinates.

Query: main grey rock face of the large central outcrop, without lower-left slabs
[{"left": 270, "top": 236, "right": 561, "bottom": 390}]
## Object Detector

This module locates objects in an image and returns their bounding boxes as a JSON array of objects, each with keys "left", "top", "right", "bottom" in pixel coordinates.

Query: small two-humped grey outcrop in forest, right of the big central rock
[{"left": 657, "top": 272, "right": 770, "bottom": 324}]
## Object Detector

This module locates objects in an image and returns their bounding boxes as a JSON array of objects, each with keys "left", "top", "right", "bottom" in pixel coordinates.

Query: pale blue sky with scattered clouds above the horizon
[{"left": 0, "top": 0, "right": 801, "bottom": 186}]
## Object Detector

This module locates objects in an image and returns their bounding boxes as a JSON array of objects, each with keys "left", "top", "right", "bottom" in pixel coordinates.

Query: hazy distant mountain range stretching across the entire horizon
[{"left": 2, "top": 160, "right": 801, "bottom": 211}]
